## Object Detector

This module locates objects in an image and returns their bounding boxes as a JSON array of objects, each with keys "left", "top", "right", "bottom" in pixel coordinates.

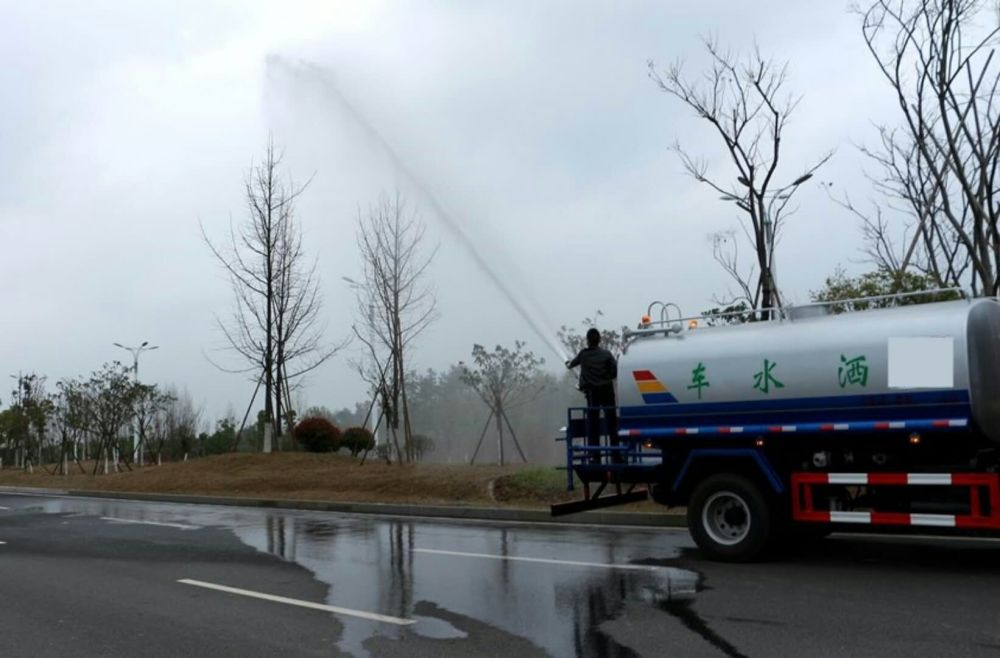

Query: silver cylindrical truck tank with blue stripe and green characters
[{"left": 618, "top": 299, "right": 1000, "bottom": 442}]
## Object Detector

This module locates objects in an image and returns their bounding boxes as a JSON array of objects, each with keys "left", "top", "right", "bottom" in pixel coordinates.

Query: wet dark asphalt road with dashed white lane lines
[{"left": 0, "top": 494, "right": 1000, "bottom": 658}]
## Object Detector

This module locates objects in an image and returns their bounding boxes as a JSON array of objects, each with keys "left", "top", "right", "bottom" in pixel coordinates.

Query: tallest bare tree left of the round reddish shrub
[{"left": 202, "top": 140, "right": 339, "bottom": 452}]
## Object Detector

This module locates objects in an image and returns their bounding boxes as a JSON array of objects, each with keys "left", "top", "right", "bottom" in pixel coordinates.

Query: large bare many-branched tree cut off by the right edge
[{"left": 844, "top": 0, "right": 1000, "bottom": 294}]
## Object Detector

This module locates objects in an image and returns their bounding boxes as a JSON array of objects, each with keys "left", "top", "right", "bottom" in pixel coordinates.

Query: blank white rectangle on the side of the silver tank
[{"left": 889, "top": 336, "right": 955, "bottom": 388}]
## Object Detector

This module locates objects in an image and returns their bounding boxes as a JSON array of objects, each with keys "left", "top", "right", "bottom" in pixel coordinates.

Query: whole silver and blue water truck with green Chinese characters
[{"left": 552, "top": 293, "right": 1000, "bottom": 561}]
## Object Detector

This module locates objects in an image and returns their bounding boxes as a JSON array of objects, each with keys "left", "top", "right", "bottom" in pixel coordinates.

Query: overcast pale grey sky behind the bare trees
[{"left": 0, "top": 0, "right": 893, "bottom": 418}]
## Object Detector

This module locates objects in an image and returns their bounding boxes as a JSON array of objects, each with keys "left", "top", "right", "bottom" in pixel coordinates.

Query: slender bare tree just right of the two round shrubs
[{"left": 354, "top": 192, "right": 438, "bottom": 461}]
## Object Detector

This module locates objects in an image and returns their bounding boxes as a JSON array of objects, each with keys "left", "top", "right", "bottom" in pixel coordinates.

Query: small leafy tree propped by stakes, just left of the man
[{"left": 459, "top": 341, "right": 545, "bottom": 466}]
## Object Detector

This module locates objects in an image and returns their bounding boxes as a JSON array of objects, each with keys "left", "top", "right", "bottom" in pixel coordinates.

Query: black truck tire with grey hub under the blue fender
[{"left": 687, "top": 473, "right": 773, "bottom": 562}]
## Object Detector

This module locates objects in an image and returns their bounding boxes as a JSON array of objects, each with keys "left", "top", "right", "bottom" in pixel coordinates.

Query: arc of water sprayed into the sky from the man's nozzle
[{"left": 266, "top": 54, "right": 567, "bottom": 363}]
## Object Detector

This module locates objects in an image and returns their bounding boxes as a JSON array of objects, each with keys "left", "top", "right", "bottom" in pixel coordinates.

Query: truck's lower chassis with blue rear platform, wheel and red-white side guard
[{"left": 551, "top": 408, "right": 1000, "bottom": 561}]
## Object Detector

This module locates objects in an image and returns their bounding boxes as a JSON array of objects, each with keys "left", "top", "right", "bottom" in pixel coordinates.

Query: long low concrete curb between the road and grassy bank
[{"left": 0, "top": 486, "right": 686, "bottom": 528}]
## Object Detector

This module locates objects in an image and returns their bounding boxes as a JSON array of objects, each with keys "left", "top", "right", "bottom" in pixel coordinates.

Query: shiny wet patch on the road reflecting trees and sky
[{"left": 7, "top": 498, "right": 700, "bottom": 657}]
